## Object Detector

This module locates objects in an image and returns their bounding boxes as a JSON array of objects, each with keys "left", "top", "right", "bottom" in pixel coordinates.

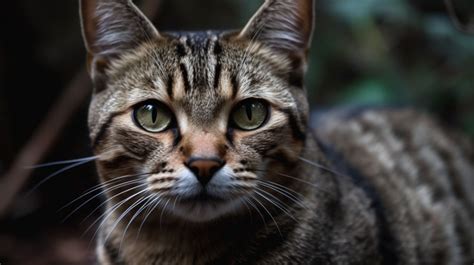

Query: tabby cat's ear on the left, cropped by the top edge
[{"left": 80, "top": 0, "right": 160, "bottom": 90}]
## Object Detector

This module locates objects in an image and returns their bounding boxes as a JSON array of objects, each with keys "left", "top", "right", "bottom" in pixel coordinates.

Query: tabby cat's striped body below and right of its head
[{"left": 100, "top": 106, "right": 474, "bottom": 264}]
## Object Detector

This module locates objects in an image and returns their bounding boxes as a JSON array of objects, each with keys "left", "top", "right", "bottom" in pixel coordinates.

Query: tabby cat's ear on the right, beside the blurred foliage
[{"left": 239, "top": 0, "right": 314, "bottom": 57}]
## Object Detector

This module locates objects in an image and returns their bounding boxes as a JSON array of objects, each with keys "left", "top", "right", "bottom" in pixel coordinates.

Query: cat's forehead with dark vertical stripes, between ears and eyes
[{"left": 103, "top": 31, "right": 291, "bottom": 122}]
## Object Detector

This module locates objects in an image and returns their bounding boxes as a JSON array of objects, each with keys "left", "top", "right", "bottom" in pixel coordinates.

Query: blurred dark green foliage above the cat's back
[{"left": 298, "top": 0, "right": 474, "bottom": 136}]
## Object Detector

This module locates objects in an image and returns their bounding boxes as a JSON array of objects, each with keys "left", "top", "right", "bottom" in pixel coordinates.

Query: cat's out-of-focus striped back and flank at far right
[{"left": 313, "top": 109, "right": 474, "bottom": 264}]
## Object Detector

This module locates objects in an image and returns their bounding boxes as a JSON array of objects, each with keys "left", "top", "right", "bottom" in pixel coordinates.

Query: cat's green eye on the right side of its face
[{"left": 231, "top": 99, "right": 268, "bottom": 131}]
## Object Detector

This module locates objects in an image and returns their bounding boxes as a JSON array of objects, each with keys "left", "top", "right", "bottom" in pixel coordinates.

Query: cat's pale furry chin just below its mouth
[{"left": 168, "top": 197, "right": 242, "bottom": 223}]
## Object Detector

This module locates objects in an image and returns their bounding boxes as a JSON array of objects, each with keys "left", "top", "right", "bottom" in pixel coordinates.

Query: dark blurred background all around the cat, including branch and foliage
[{"left": 0, "top": 0, "right": 474, "bottom": 265}]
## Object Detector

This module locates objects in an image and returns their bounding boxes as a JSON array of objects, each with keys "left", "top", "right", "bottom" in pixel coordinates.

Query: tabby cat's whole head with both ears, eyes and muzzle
[{"left": 81, "top": 0, "right": 314, "bottom": 222}]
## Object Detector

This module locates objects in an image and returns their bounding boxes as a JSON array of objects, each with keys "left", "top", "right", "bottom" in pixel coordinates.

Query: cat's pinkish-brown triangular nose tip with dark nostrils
[{"left": 186, "top": 158, "right": 225, "bottom": 186}]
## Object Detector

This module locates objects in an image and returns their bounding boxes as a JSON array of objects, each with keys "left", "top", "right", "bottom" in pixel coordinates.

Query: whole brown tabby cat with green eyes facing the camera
[{"left": 80, "top": 0, "right": 474, "bottom": 265}]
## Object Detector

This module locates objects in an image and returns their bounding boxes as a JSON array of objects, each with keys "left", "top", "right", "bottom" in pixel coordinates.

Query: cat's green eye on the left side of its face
[{"left": 133, "top": 103, "right": 172, "bottom": 133}]
